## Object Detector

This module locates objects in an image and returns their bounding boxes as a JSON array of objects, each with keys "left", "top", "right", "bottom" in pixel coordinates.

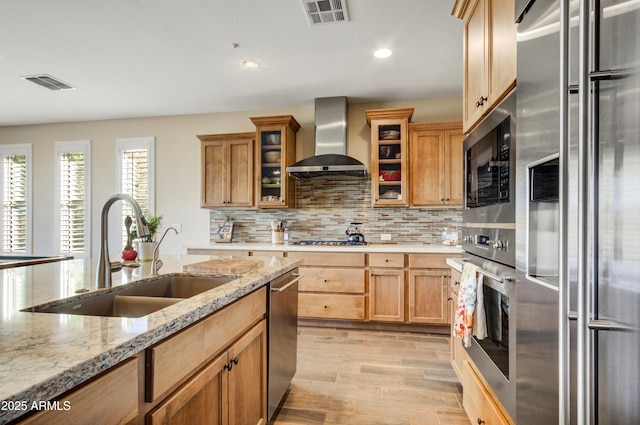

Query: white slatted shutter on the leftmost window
[{"left": 2, "top": 154, "right": 29, "bottom": 253}]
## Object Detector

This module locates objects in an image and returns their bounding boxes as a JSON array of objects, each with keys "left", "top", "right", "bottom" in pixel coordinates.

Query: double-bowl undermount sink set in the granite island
[{"left": 23, "top": 275, "right": 238, "bottom": 317}]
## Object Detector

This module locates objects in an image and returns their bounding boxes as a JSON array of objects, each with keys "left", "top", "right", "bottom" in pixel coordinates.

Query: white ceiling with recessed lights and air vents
[{"left": 0, "top": 0, "right": 462, "bottom": 126}]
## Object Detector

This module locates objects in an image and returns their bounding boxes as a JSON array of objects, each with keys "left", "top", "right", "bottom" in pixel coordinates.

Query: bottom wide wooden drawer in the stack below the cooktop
[{"left": 298, "top": 293, "right": 364, "bottom": 320}]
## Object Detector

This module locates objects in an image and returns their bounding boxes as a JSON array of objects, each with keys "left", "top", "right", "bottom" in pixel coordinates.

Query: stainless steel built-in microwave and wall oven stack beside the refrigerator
[{"left": 462, "top": 91, "right": 517, "bottom": 417}]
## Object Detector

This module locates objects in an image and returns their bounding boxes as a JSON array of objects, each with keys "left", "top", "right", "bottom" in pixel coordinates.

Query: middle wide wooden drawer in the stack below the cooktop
[{"left": 299, "top": 267, "right": 364, "bottom": 293}]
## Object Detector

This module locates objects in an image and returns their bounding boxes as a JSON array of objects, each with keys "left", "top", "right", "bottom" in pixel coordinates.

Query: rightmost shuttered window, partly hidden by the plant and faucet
[{"left": 118, "top": 137, "right": 155, "bottom": 246}]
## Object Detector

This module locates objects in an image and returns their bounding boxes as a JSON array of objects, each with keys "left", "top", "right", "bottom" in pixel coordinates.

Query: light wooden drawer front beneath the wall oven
[{"left": 462, "top": 360, "right": 511, "bottom": 425}]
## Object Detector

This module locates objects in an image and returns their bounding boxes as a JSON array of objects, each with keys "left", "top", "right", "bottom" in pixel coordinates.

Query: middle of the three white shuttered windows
[{"left": 56, "top": 141, "right": 91, "bottom": 257}]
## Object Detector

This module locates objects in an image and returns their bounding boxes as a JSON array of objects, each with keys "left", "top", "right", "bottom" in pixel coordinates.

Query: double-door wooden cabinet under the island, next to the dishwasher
[{"left": 147, "top": 320, "right": 267, "bottom": 425}]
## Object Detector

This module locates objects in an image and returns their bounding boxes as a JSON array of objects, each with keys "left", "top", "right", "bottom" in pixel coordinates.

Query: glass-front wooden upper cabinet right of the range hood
[{"left": 366, "top": 108, "right": 413, "bottom": 207}]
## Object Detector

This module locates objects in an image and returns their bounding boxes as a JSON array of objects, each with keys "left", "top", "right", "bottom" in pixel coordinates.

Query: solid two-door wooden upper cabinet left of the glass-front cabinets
[{"left": 198, "top": 133, "right": 255, "bottom": 208}]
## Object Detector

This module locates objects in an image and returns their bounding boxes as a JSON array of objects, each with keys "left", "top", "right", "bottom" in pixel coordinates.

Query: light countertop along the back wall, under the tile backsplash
[{"left": 185, "top": 242, "right": 462, "bottom": 254}]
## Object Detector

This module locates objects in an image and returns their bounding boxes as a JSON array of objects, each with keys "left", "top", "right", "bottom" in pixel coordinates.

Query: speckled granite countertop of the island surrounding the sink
[{"left": 0, "top": 255, "right": 301, "bottom": 424}]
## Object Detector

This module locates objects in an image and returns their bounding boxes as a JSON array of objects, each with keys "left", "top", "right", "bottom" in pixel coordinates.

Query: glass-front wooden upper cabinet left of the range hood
[{"left": 251, "top": 115, "right": 300, "bottom": 208}]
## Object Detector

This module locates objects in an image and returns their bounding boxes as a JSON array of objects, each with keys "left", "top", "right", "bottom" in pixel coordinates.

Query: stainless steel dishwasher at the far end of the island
[{"left": 267, "top": 269, "right": 302, "bottom": 421}]
